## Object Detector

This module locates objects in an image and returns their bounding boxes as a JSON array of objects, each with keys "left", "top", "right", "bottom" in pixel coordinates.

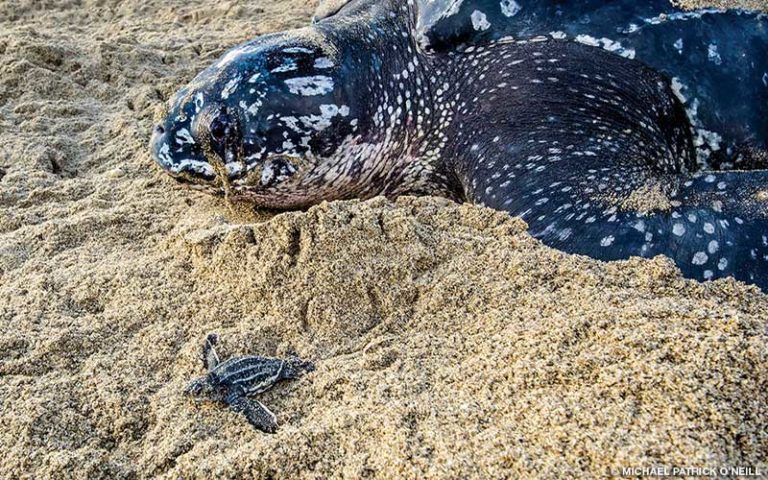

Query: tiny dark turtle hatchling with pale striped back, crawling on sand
[{"left": 185, "top": 334, "right": 315, "bottom": 433}]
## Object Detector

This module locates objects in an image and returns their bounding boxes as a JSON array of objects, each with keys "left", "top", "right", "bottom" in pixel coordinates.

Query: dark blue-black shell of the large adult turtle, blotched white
[{"left": 312, "top": 0, "right": 768, "bottom": 168}]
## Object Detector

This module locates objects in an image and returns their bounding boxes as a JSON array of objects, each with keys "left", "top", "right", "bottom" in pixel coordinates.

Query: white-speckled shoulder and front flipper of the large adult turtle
[{"left": 452, "top": 42, "right": 768, "bottom": 289}]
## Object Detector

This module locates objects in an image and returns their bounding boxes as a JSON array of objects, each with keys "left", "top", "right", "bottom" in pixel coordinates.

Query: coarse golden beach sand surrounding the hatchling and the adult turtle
[{"left": 0, "top": 0, "right": 768, "bottom": 479}]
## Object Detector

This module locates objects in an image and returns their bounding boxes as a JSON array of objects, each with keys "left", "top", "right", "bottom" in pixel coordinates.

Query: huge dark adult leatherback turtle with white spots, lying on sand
[{"left": 152, "top": 0, "right": 768, "bottom": 289}]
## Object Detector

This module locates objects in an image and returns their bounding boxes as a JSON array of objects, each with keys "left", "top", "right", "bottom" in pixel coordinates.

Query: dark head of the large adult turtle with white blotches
[{"left": 151, "top": 28, "right": 368, "bottom": 208}]
